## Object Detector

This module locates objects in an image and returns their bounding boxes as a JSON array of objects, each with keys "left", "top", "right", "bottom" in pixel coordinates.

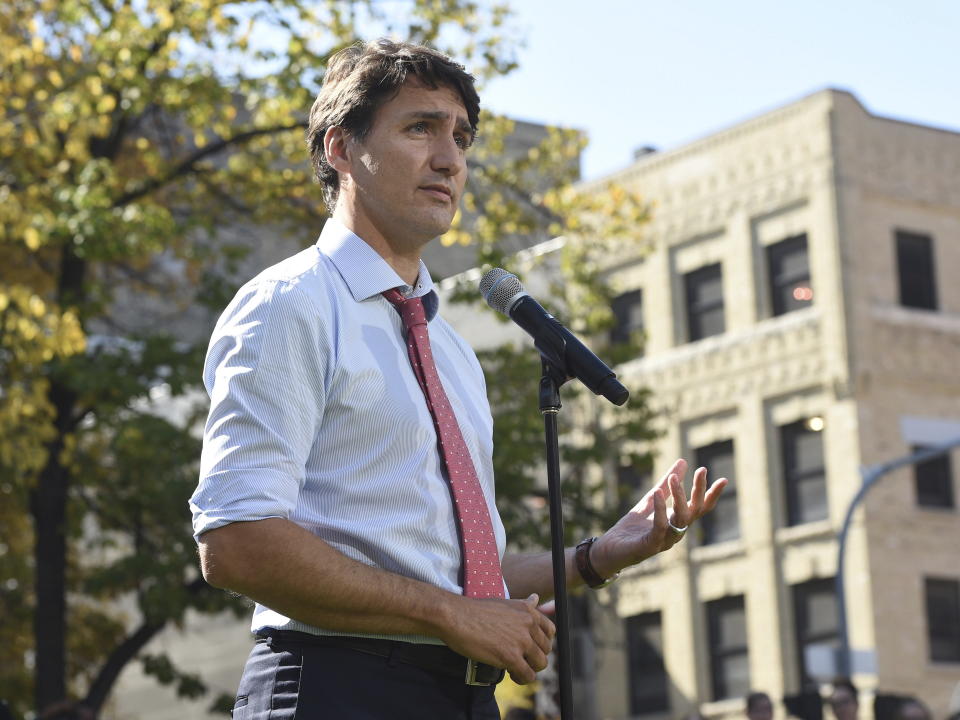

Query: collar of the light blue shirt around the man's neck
[{"left": 317, "top": 217, "right": 440, "bottom": 320}]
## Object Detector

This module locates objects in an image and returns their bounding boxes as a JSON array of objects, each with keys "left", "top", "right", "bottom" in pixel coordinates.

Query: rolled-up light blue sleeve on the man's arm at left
[{"left": 190, "top": 281, "right": 330, "bottom": 537}]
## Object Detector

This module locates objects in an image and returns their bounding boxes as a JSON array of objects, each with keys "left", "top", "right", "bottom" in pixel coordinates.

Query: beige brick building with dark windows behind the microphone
[{"left": 568, "top": 90, "right": 960, "bottom": 718}]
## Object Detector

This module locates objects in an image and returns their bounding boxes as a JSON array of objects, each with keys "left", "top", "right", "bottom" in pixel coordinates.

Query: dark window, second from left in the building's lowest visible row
[{"left": 707, "top": 595, "right": 750, "bottom": 700}]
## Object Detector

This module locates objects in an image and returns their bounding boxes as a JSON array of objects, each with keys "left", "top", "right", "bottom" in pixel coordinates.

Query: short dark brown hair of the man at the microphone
[{"left": 307, "top": 38, "right": 480, "bottom": 212}]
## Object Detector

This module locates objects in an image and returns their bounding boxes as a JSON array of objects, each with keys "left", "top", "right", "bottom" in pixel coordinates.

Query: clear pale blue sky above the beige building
[{"left": 481, "top": 0, "right": 960, "bottom": 180}]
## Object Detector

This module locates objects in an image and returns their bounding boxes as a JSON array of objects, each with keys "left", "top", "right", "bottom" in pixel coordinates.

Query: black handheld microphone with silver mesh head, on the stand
[{"left": 480, "top": 268, "right": 630, "bottom": 405}]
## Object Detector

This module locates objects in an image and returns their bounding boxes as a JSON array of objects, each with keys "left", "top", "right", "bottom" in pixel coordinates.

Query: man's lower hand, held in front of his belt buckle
[{"left": 440, "top": 595, "right": 557, "bottom": 685}]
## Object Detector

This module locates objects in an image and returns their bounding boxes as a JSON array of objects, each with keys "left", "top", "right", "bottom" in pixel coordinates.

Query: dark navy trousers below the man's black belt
[{"left": 232, "top": 639, "right": 500, "bottom": 720}]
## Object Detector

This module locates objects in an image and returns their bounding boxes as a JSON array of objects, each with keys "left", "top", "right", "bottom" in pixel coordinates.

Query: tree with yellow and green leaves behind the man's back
[{"left": 0, "top": 0, "right": 652, "bottom": 713}]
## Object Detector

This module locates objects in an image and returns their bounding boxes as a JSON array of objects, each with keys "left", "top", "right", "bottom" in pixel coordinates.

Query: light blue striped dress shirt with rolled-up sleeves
[{"left": 190, "top": 219, "right": 505, "bottom": 642}]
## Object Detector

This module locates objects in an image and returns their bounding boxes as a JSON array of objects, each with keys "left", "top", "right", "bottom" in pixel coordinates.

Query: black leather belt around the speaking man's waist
[{"left": 257, "top": 628, "right": 504, "bottom": 685}]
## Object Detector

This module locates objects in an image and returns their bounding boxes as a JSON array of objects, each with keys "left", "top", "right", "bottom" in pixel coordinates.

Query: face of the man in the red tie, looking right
[{"left": 340, "top": 83, "right": 472, "bottom": 252}]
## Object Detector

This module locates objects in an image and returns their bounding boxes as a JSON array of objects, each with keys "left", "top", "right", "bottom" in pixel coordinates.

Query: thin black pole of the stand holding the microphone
[{"left": 540, "top": 355, "right": 573, "bottom": 720}]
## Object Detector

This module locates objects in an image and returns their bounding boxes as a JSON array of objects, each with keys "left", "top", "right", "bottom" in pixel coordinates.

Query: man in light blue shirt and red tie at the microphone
[{"left": 191, "top": 40, "right": 724, "bottom": 720}]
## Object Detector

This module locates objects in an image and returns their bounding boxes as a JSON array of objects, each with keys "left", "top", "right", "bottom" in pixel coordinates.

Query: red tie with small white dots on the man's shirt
[{"left": 383, "top": 289, "right": 504, "bottom": 598}]
